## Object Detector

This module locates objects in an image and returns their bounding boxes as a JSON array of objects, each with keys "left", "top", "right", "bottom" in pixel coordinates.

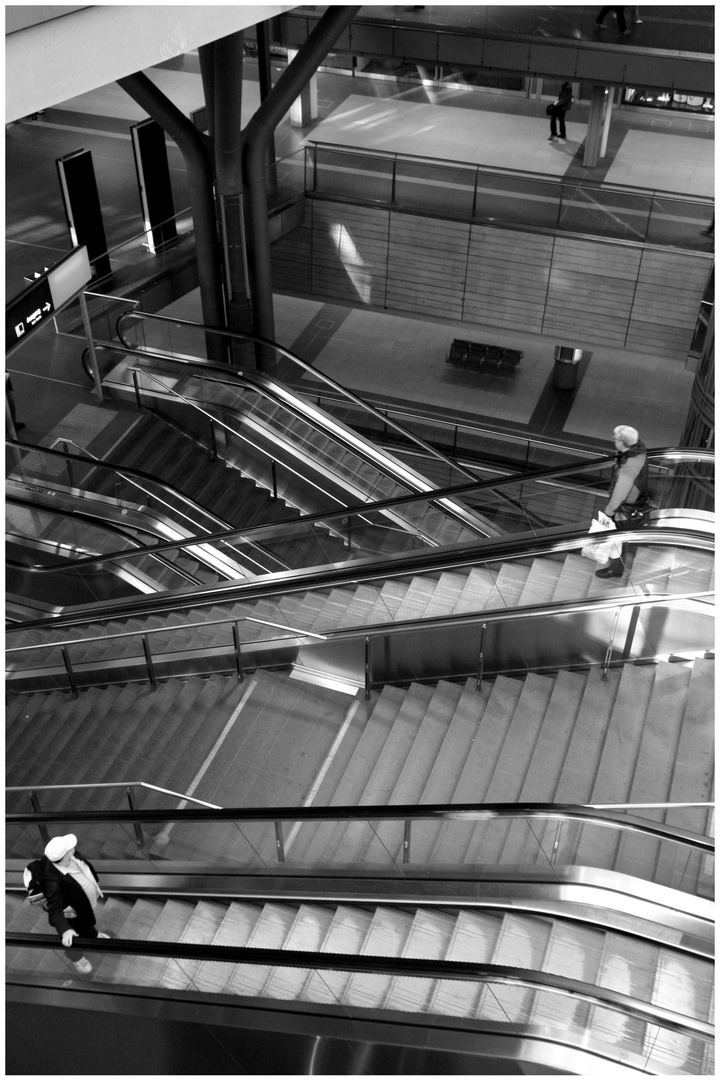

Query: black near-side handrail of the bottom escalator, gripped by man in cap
[{"left": 5, "top": 931, "right": 715, "bottom": 1040}]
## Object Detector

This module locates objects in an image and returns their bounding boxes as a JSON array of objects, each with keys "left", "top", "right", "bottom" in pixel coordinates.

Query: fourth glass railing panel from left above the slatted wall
[{"left": 558, "top": 181, "right": 651, "bottom": 242}]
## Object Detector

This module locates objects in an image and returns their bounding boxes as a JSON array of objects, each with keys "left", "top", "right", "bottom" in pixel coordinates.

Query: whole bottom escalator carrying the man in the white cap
[{"left": 6, "top": 811, "right": 714, "bottom": 1076}]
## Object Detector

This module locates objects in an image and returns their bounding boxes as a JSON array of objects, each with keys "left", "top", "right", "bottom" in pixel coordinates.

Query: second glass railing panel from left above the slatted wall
[{"left": 395, "top": 158, "right": 476, "bottom": 219}]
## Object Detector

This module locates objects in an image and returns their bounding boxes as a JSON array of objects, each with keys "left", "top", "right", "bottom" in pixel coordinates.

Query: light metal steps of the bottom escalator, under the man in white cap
[{"left": 5, "top": 893, "right": 712, "bottom": 1074}]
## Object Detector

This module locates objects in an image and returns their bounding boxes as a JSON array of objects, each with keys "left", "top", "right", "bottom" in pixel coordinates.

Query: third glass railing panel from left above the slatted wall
[{"left": 475, "top": 172, "right": 560, "bottom": 229}]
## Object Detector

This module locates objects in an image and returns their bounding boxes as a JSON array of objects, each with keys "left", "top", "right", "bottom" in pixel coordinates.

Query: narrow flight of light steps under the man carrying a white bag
[{"left": 8, "top": 545, "right": 715, "bottom": 671}]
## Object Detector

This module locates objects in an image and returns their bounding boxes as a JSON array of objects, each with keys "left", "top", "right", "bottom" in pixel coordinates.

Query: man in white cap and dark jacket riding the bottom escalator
[{"left": 41, "top": 833, "right": 110, "bottom": 975}]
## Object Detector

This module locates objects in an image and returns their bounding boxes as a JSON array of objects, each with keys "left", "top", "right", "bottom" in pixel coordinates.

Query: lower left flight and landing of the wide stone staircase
[{"left": 5, "top": 672, "right": 358, "bottom": 859}]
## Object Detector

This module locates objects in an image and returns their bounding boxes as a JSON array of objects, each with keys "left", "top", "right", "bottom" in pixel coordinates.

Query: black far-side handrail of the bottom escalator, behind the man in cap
[{"left": 5, "top": 803, "right": 715, "bottom": 854}]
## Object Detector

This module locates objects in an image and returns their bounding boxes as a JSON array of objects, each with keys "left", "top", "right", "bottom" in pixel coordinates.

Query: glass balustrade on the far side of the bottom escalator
[{"left": 5, "top": 799, "right": 715, "bottom": 898}]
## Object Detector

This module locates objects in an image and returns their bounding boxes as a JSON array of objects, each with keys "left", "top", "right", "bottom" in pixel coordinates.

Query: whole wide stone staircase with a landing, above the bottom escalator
[{"left": 6, "top": 659, "right": 715, "bottom": 896}]
